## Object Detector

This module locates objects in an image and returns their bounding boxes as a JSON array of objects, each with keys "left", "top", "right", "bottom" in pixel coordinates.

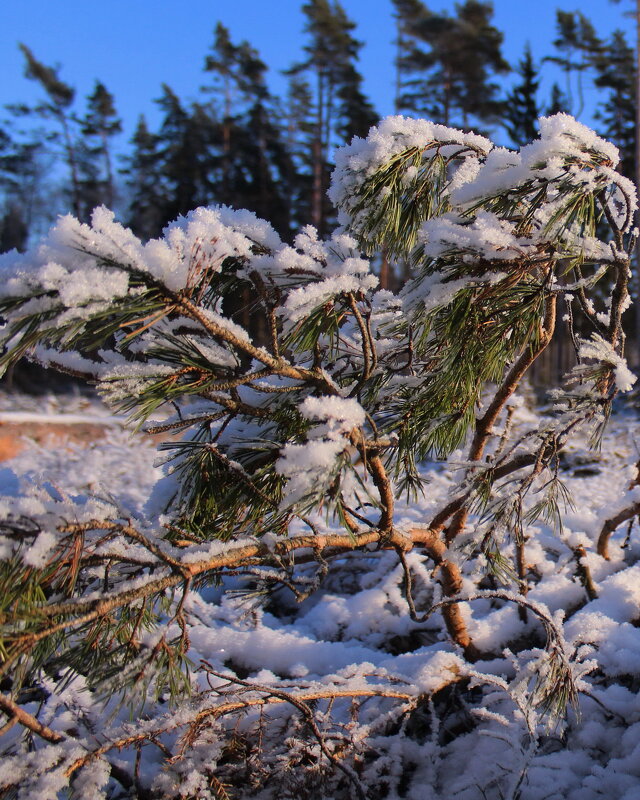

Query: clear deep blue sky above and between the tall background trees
[{"left": 0, "top": 0, "right": 635, "bottom": 145}]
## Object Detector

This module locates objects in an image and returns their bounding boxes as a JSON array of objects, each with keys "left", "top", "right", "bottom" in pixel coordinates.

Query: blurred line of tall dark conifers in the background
[{"left": 0, "top": 0, "right": 636, "bottom": 250}]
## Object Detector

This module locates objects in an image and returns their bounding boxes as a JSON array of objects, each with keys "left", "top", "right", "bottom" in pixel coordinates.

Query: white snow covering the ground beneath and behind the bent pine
[{"left": 0, "top": 395, "right": 640, "bottom": 800}]
